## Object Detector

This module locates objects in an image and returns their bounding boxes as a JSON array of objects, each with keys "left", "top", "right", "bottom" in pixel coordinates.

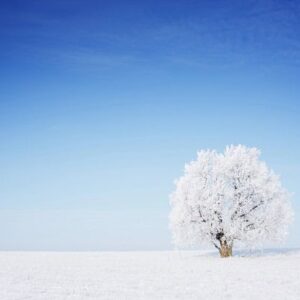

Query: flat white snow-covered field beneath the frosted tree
[{"left": 0, "top": 251, "right": 300, "bottom": 300}]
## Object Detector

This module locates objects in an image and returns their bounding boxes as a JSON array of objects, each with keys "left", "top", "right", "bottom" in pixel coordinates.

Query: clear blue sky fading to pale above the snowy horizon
[{"left": 0, "top": 0, "right": 300, "bottom": 250}]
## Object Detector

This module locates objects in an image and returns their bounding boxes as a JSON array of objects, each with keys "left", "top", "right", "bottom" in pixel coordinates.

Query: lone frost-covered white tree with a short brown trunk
[{"left": 170, "top": 145, "right": 292, "bottom": 257}]
